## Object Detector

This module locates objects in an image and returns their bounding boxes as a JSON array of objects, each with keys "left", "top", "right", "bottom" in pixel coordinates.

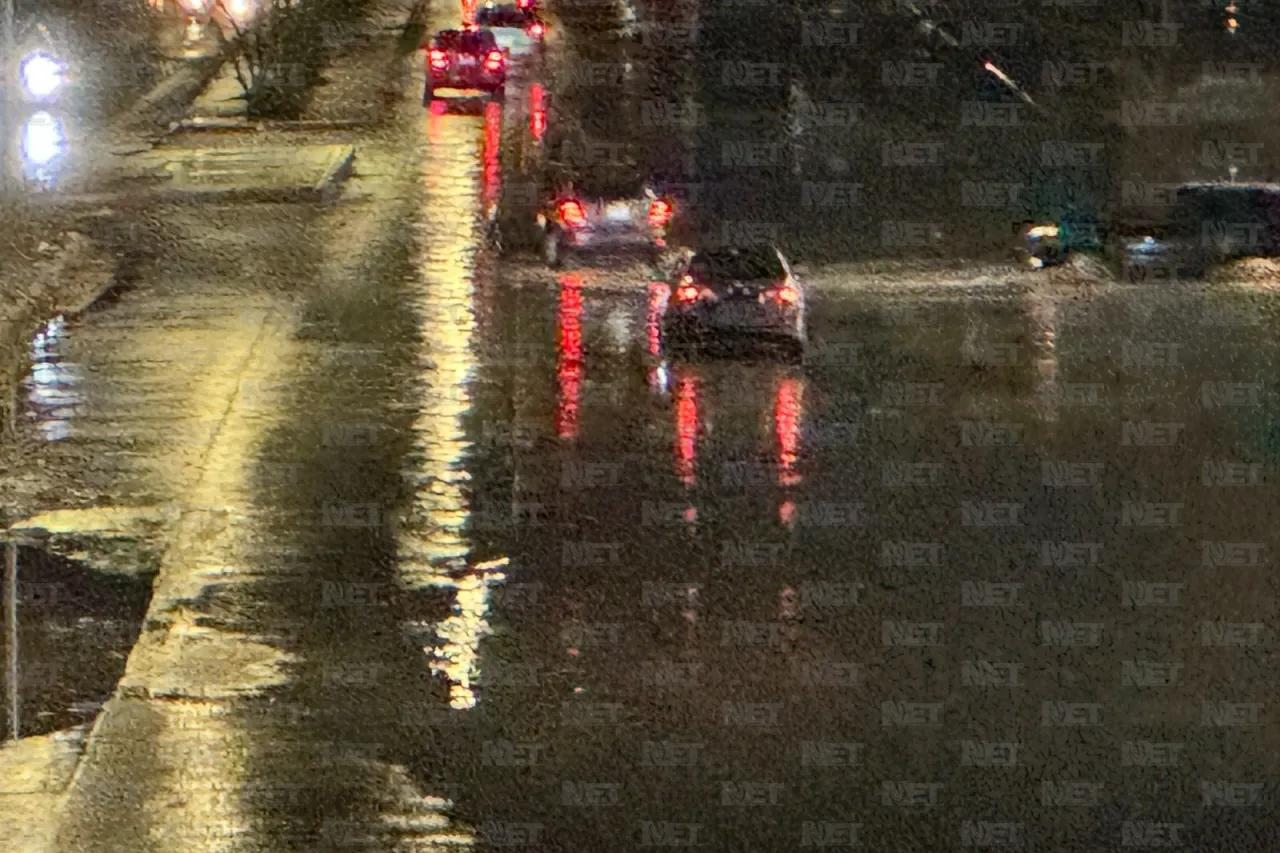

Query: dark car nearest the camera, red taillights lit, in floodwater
[{"left": 663, "top": 246, "right": 808, "bottom": 356}]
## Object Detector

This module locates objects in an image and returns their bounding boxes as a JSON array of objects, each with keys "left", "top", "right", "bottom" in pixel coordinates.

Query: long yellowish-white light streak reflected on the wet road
[{"left": 397, "top": 104, "right": 507, "bottom": 711}]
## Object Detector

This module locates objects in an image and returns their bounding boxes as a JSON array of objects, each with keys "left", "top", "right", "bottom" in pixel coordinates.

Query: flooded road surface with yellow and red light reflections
[{"left": 0, "top": 6, "right": 1280, "bottom": 853}]
